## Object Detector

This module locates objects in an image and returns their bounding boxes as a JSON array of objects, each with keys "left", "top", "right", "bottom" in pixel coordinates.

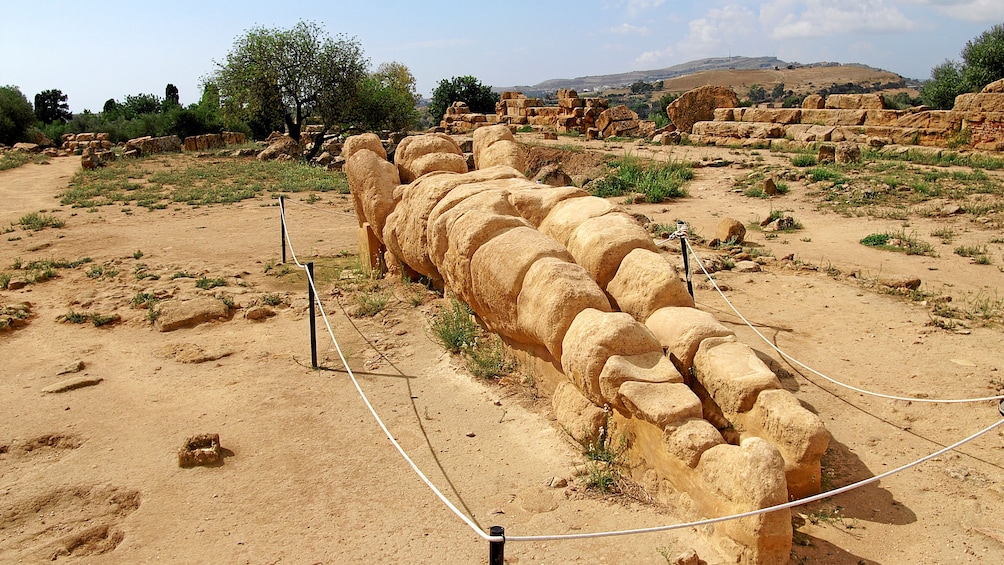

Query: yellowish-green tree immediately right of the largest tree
[{"left": 355, "top": 61, "right": 421, "bottom": 130}]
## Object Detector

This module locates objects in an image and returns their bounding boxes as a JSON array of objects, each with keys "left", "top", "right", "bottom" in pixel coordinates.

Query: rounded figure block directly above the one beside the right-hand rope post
[{"left": 566, "top": 214, "right": 657, "bottom": 288}]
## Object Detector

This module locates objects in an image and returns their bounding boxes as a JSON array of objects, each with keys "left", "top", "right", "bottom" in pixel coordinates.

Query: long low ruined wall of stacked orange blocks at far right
[{"left": 690, "top": 80, "right": 1004, "bottom": 151}]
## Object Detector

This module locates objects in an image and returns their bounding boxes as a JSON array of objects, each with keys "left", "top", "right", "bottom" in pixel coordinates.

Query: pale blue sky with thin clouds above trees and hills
[{"left": 0, "top": 0, "right": 1004, "bottom": 111}]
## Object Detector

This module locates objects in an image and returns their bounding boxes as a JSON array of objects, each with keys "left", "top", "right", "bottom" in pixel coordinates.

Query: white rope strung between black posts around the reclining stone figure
[{"left": 279, "top": 203, "right": 1004, "bottom": 544}]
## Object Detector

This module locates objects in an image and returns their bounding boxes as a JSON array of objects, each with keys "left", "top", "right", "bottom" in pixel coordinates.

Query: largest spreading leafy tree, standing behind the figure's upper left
[{"left": 213, "top": 21, "right": 367, "bottom": 147}]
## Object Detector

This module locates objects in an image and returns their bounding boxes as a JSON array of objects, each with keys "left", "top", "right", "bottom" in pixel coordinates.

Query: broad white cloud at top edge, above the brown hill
[{"left": 760, "top": 0, "right": 917, "bottom": 39}]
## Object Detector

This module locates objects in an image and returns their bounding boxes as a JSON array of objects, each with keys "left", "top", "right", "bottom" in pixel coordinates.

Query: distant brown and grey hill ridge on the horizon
[{"left": 493, "top": 57, "right": 914, "bottom": 95}]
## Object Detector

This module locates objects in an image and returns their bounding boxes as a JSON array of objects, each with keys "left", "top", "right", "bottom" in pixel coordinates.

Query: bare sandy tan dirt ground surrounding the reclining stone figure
[{"left": 0, "top": 146, "right": 1004, "bottom": 564}]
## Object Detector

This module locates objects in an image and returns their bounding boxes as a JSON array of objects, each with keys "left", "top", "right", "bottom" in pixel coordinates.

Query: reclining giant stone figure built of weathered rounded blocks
[{"left": 342, "top": 125, "right": 829, "bottom": 564}]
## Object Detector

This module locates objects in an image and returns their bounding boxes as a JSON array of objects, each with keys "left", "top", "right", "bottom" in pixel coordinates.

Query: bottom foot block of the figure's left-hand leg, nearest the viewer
[{"left": 697, "top": 438, "right": 791, "bottom": 564}]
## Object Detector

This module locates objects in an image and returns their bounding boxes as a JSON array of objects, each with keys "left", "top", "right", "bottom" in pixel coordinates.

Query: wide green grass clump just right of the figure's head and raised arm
[{"left": 591, "top": 156, "right": 694, "bottom": 203}]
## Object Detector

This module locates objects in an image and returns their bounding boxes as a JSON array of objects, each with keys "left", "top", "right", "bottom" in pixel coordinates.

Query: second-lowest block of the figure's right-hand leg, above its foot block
[{"left": 694, "top": 337, "right": 781, "bottom": 419}]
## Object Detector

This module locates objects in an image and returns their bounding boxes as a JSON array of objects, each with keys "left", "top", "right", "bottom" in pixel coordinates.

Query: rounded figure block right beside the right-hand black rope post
[{"left": 606, "top": 249, "right": 694, "bottom": 322}]
